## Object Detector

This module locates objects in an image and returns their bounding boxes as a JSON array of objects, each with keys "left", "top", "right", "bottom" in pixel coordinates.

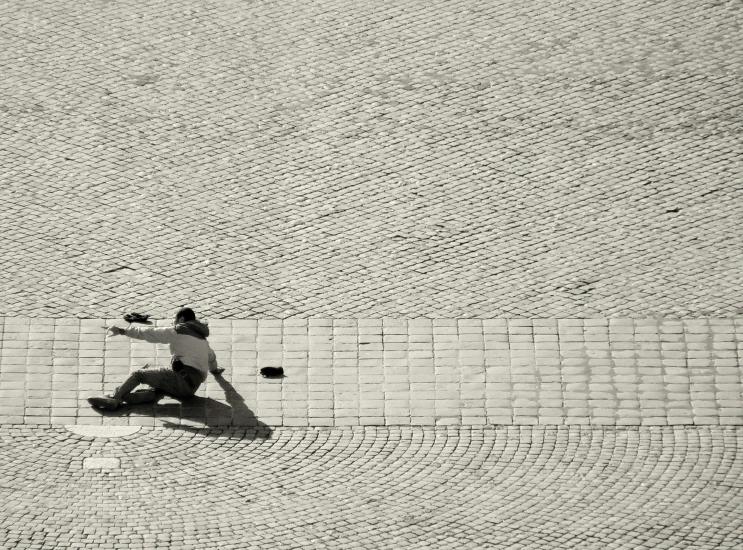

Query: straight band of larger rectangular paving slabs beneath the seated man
[{"left": 0, "top": 318, "right": 743, "bottom": 427}]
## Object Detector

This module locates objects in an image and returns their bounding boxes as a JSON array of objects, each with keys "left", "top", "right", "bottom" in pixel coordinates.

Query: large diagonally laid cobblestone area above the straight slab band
[{"left": 0, "top": 0, "right": 743, "bottom": 319}]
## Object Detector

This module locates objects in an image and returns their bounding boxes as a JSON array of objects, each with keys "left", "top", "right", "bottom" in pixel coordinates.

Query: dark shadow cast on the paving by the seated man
[{"left": 94, "top": 376, "right": 273, "bottom": 439}]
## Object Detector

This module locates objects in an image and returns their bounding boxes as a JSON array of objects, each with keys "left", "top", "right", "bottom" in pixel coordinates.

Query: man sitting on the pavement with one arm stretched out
[{"left": 88, "top": 308, "right": 224, "bottom": 410}]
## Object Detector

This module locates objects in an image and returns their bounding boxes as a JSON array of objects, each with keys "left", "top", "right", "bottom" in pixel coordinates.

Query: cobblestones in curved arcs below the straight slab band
[{"left": 0, "top": 427, "right": 743, "bottom": 550}]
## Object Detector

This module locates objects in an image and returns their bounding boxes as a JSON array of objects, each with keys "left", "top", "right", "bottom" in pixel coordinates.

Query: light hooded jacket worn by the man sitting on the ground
[{"left": 124, "top": 321, "right": 218, "bottom": 376}]
